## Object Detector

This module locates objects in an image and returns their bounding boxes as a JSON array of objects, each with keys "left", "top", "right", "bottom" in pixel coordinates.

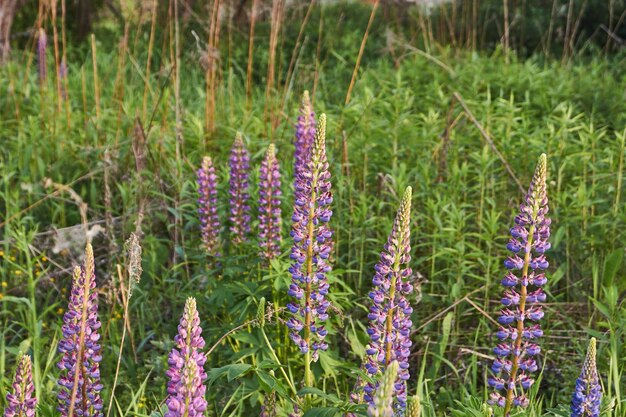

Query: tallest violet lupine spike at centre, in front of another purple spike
[{"left": 287, "top": 115, "right": 333, "bottom": 364}]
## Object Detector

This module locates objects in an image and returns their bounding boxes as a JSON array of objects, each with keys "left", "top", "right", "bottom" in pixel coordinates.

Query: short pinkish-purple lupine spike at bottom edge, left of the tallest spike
[{"left": 165, "top": 297, "right": 207, "bottom": 417}]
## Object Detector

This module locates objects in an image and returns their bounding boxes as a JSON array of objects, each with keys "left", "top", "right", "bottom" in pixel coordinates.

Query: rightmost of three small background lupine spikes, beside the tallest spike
[{"left": 259, "top": 144, "right": 282, "bottom": 259}]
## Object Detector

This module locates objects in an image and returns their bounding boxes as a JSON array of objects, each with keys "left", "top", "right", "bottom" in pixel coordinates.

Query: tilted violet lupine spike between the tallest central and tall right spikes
[{"left": 363, "top": 187, "right": 413, "bottom": 412}]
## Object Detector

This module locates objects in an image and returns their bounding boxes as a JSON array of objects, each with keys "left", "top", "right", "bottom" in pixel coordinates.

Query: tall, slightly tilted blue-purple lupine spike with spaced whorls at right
[{"left": 489, "top": 154, "right": 550, "bottom": 416}]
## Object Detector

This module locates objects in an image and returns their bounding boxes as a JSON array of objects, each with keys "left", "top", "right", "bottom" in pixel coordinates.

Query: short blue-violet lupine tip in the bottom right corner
[{"left": 572, "top": 337, "right": 602, "bottom": 417}]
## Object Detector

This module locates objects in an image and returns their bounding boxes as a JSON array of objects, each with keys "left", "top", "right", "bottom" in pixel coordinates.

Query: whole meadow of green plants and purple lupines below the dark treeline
[{"left": 0, "top": 2, "right": 626, "bottom": 417}]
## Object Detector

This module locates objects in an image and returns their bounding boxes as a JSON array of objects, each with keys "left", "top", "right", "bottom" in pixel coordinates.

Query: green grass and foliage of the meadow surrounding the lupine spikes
[{"left": 0, "top": 1, "right": 626, "bottom": 416}]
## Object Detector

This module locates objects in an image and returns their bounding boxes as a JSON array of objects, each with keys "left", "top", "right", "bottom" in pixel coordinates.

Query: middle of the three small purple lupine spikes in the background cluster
[{"left": 229, "top": 132, "right": 250, "bottom": 245}]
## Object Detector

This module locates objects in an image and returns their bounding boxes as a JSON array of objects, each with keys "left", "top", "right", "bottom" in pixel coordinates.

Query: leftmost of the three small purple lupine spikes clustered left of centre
[{"left": 197, "top": 156, "right": 220, "bottom": 257}]
